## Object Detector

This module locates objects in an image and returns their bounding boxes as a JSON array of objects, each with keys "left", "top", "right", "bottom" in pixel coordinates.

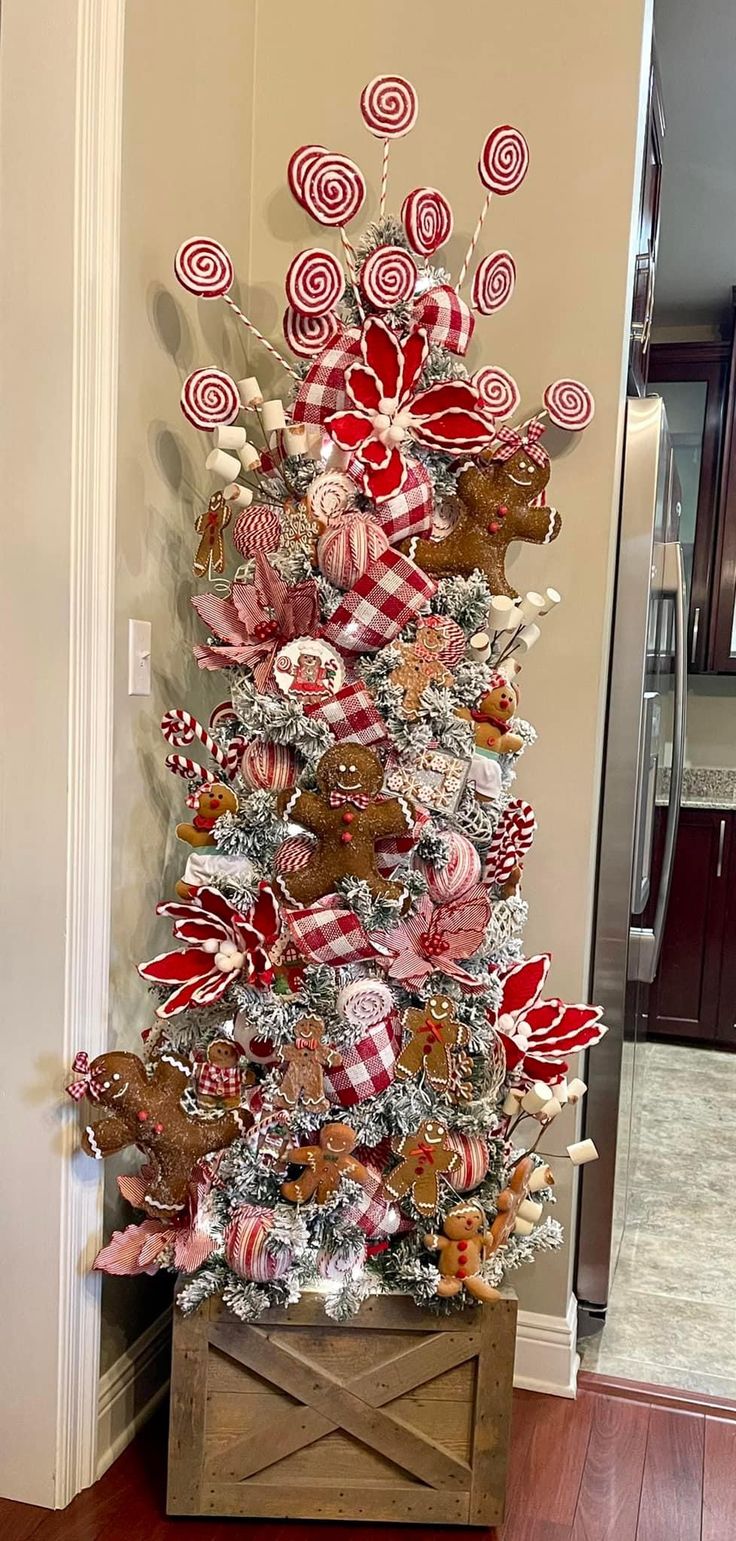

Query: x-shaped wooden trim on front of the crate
[{"left": 208, "top": 1322, "right": 480, "bottom": 1492}]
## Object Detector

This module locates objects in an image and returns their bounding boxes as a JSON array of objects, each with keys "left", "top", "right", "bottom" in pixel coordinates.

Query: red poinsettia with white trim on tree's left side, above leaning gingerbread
[{"left": 139, "top": 883, "right": 280, "bottom": 1017}]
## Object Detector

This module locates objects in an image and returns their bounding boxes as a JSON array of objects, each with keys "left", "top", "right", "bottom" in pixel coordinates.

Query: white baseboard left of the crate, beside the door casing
[{"left": 97, "top": 1305, "right": 171, "bottom": 1478}]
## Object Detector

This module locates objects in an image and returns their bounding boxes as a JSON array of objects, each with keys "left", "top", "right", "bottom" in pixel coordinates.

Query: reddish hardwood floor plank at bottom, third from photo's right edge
[{"left": 571, "top": 1396, "right": 650, "bottom": 1541}]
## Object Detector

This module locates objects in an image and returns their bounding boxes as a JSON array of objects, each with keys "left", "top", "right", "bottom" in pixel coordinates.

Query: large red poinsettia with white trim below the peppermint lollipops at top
[{"left": 325, "top": 316, "right": 494, "bottom": 502}]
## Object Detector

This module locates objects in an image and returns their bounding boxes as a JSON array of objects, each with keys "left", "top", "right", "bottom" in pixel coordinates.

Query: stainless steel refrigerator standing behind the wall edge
[{"left": 576, "top": 396, "right": 687, "bottom": 1333}]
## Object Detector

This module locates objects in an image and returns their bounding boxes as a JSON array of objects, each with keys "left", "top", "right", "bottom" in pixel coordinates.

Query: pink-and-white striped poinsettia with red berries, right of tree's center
[{"left": 379, "top": 885, "right": 491, "bottom": 991}]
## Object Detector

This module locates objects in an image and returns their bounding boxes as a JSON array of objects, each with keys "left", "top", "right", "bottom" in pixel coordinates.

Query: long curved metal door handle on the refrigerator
[{"left": 630, "top": 541, "right": 687, "bottom": 985}]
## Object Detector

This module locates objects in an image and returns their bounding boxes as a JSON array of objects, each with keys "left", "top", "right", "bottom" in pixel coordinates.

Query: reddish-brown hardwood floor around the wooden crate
[{"left": 0, "top": 1376, "right": 736, "bottom": 1541}]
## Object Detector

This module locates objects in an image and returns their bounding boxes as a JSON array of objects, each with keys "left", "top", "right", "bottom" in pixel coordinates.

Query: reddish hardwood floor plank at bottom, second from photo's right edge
[{"left": 636, "top": 1407, "right": 705, "bottom": 1541}]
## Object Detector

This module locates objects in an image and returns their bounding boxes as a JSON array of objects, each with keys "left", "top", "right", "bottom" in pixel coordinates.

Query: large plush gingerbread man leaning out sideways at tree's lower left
[{"left": 66, "top": 1051, "right": 253, "bottom": 1217}]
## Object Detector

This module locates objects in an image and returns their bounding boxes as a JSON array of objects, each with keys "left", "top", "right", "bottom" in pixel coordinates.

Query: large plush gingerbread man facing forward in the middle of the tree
[{"left": 277, "top": 740, "right": 414, "bottom": 905}]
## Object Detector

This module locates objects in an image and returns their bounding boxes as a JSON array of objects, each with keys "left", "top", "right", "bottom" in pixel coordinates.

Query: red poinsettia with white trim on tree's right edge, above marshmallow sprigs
[{"left": 496, "top": 952, "right": 608, "bottom": 1083}]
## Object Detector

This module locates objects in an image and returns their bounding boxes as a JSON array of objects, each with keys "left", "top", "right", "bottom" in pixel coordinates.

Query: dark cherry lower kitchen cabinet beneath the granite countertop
[{"left": 645, "top": 807, "right": 736, "bottom": 1048}]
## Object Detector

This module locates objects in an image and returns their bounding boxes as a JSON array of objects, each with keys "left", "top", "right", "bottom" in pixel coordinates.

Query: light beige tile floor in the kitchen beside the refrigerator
[{"left": 577, "top": 1043, "right": 736, "bottom": 1398}]
